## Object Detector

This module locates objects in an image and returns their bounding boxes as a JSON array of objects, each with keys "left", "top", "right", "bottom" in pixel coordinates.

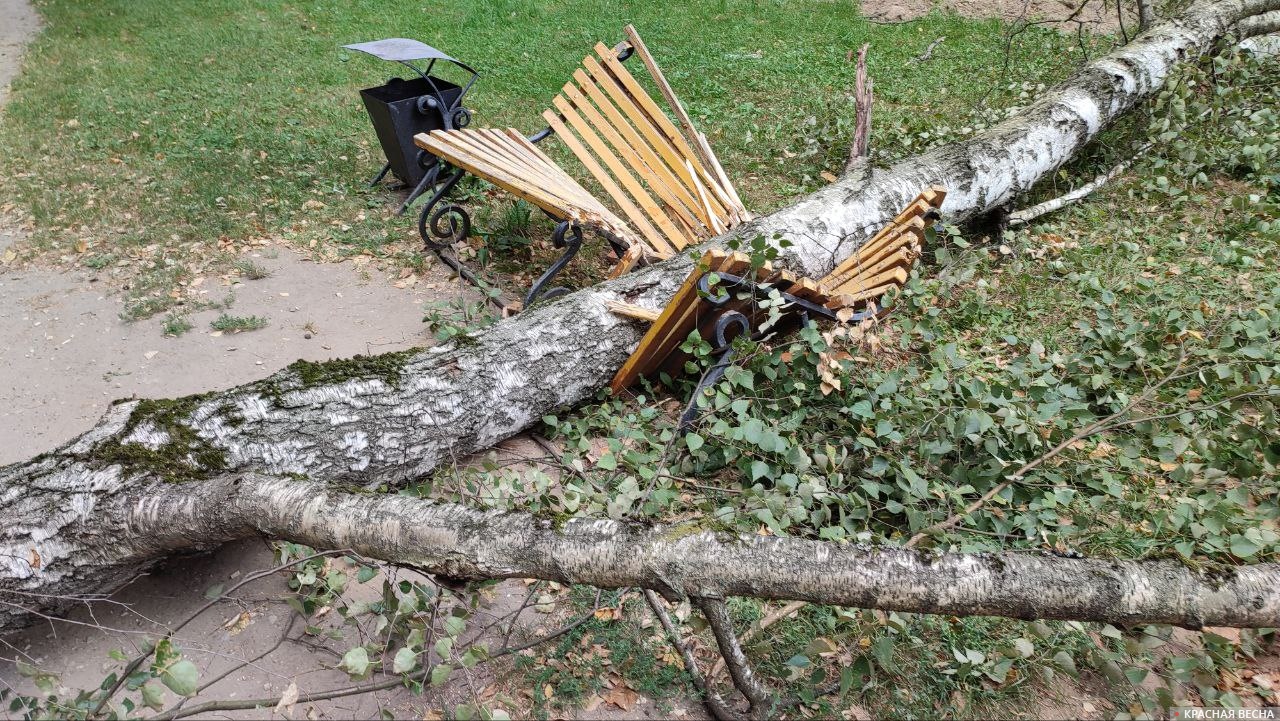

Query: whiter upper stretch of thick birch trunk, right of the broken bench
[{"left": 742, "top": 0, "right": 1280, "bottom": 278}]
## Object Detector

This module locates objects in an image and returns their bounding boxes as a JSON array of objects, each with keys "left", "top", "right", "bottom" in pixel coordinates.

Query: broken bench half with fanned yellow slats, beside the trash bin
[{"left": 413, "top": 26, "right": 751, "bottom": 306}]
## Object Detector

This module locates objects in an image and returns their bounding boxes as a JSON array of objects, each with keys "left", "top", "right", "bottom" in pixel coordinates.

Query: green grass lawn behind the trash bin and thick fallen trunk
[{"left": 0, "top": 0, "right": 1100, "bottom": 316}]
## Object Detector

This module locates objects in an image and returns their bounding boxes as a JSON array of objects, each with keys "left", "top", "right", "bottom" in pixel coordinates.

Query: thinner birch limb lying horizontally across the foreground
[{"left": 0, "top": 474, "right": 1280, "bottom": 628}]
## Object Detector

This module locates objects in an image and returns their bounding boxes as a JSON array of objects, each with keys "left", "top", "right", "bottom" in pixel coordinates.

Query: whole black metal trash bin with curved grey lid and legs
[{"left": 343, "top": 37, "right": 480, "bottom": 213}]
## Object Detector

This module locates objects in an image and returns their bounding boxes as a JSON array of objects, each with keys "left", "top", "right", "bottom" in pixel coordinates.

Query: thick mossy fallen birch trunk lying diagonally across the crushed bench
[{"left": 0, "top": 0, "right": 1280, "bottom": 630}]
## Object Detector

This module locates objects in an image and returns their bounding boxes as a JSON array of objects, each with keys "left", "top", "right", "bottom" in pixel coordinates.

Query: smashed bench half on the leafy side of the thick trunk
[{"left": 609, "top": 186, "right": 946, "bottom": 432}]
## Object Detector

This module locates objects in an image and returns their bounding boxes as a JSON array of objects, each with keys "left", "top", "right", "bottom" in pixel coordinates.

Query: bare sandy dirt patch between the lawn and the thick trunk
[{"left": 0, "top": 253, "right": 462, "bottom": 464}]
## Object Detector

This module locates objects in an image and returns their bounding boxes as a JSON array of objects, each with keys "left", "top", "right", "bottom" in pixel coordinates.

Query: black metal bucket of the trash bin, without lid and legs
[{"left": 360, "top": 78, "right": 462, "bottom": 186}]
